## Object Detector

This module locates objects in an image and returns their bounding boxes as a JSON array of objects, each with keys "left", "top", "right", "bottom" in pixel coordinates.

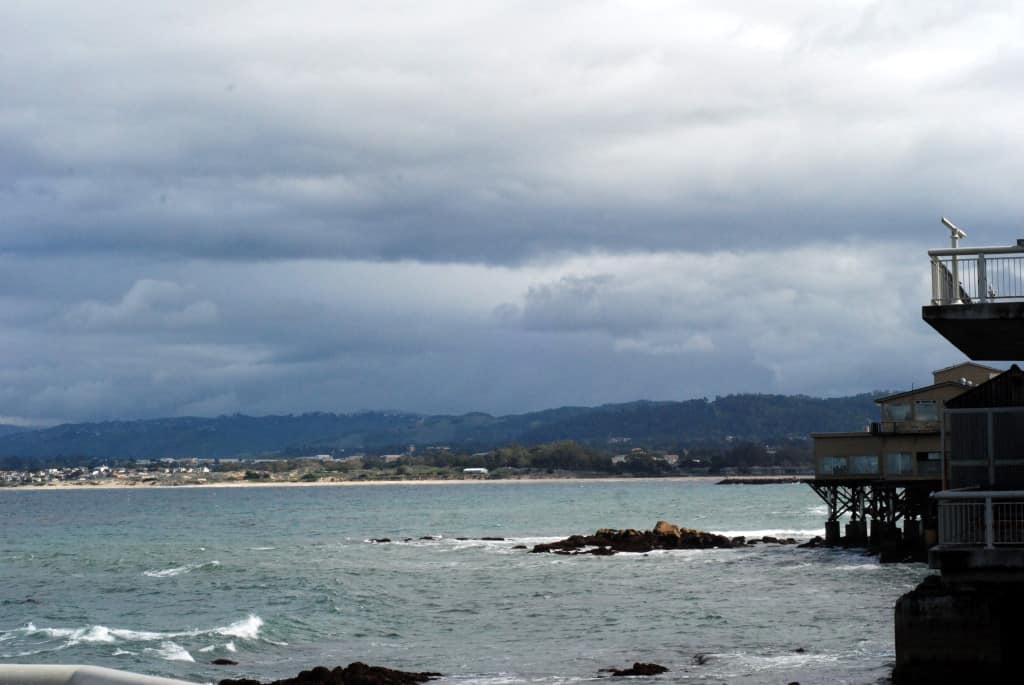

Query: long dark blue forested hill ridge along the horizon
[{"left": 0, "top": 393, "right": 878, "bottom": 465}]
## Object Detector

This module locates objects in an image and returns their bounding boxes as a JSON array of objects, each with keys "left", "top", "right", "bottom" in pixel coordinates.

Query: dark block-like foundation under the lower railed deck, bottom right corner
[{"left": 893, "top": 575, "right": 1024, "bottom": 685}]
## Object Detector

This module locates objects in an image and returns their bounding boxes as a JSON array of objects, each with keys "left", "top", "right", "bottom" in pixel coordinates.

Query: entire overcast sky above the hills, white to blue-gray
[{"left": 0, "top": 0, "right": 1024, "bottom": 424}]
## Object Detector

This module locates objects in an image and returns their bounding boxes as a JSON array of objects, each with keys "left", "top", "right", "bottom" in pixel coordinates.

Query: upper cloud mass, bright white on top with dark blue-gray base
[{"left": 6, "top": 2, "right": 1021, "bottom": 263}]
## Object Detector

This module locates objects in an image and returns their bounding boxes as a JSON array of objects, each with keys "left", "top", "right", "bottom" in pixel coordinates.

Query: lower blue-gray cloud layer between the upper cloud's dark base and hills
[{"left": 0, "top": 244, "right": 955, "bottom": 418}]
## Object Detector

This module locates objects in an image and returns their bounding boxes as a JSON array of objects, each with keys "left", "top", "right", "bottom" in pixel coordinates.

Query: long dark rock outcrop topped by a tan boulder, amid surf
[{"left": 530, "top": 521, "right": 737, "bottom": 555}]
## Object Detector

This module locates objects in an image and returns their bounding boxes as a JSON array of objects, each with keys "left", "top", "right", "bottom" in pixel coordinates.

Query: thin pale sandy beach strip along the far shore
[{"left": 0, "top": 476, "right": 753, "bottom": 493}]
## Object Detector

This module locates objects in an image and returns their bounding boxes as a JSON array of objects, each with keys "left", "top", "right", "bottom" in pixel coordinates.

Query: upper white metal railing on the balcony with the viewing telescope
[{"left": 928, "top": 246, "right": 1024, "bottom": 305}]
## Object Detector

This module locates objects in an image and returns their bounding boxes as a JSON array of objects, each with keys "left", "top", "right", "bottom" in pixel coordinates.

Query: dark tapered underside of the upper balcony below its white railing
[{"left": 921, "top": 301, "right": 1024, "bottom": 361}]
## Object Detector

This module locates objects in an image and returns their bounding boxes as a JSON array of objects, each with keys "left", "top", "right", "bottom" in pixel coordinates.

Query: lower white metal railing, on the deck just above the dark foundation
[{"left": 932, "top": 490, "right": 1024, "bottom": 549}]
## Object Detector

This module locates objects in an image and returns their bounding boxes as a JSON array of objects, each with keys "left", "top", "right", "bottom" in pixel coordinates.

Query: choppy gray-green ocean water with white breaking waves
[{"left": 0, "top": 480, "right": 928, "bottom": 685}]
